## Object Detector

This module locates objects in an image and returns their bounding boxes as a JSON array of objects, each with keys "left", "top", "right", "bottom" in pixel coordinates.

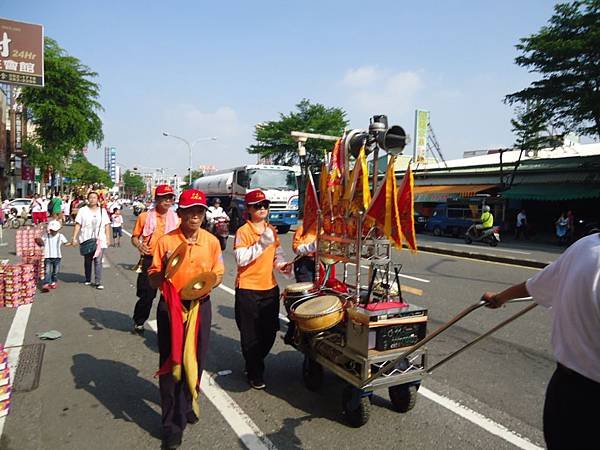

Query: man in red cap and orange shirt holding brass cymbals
[{"left": 148, "top": 189, "right": 225, "bottom": 449}]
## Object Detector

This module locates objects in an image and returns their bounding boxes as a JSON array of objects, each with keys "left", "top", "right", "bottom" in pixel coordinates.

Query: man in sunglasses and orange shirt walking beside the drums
[{"left": 234, "top": 189, "right": 292, "bottom": 389}]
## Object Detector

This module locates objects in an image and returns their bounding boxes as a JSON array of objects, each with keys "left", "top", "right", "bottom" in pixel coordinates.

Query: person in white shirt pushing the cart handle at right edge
[{"left": 482, "top": 233, "right": 600, "bottom": 450}]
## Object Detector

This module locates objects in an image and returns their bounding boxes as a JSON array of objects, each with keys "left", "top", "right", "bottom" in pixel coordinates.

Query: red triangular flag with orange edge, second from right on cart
[{"left": 365, "top": 156, "right": 402, "bottom": 249}]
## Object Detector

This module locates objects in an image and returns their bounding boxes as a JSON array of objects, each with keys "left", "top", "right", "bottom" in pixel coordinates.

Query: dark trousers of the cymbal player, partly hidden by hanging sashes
[{"left": 156, "top": 297, "right": 212, "bottom": 438}]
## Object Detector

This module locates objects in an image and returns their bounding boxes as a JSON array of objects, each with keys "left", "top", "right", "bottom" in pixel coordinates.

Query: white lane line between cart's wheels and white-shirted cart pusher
[{"left": 419, "top": 386, "right": 543, "bottom": 450}]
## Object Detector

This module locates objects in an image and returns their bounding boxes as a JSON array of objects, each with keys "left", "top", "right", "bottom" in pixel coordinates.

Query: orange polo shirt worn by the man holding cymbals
[{"left": 148, "top": 228, "right": 225, "bottom": 291}]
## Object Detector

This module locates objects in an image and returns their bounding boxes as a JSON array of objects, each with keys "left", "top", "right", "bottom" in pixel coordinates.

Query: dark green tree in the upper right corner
[{"left": 505, "top": 0, "right": 600, "bottom": 136}]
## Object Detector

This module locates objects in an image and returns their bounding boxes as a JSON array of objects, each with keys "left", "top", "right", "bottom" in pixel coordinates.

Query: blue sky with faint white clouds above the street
[{"left": 0, "top": 0, "right": 555, "bottom": 173}]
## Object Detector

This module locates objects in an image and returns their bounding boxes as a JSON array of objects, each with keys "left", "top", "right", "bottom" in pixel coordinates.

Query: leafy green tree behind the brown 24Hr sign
[{"left": 19, "top": 37, "right": 104, "bottom": 174}]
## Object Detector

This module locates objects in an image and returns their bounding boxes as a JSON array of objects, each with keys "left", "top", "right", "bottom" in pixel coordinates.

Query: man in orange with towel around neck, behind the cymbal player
[{"left": 131, "top": 184, "right": 179, "bottom": 335}]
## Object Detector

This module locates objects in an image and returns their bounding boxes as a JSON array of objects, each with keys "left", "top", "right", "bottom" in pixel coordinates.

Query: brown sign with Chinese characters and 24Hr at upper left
[{"left": 0, "top": 18, "right": 44, "bottom": 87}]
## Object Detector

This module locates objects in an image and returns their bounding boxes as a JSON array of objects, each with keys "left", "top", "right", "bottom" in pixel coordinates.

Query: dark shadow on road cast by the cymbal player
[{"left": 71, "top": 353, "right": 161, "bottom": 438}]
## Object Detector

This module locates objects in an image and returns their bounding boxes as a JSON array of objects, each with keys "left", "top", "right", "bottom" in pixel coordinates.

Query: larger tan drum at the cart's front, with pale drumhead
[{"left": 292, "top": 295, "right": 344, "bottom": 333}]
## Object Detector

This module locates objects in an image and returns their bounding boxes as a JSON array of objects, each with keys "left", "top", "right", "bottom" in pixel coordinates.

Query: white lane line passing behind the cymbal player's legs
[{"left": 147, "top": 320, "right": 277, "bottom": 450}]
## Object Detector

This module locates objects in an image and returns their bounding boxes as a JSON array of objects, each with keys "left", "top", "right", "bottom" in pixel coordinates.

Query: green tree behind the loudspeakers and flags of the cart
[{"left": 248, "top": 99, "right": 348, "bottom": 166}]
